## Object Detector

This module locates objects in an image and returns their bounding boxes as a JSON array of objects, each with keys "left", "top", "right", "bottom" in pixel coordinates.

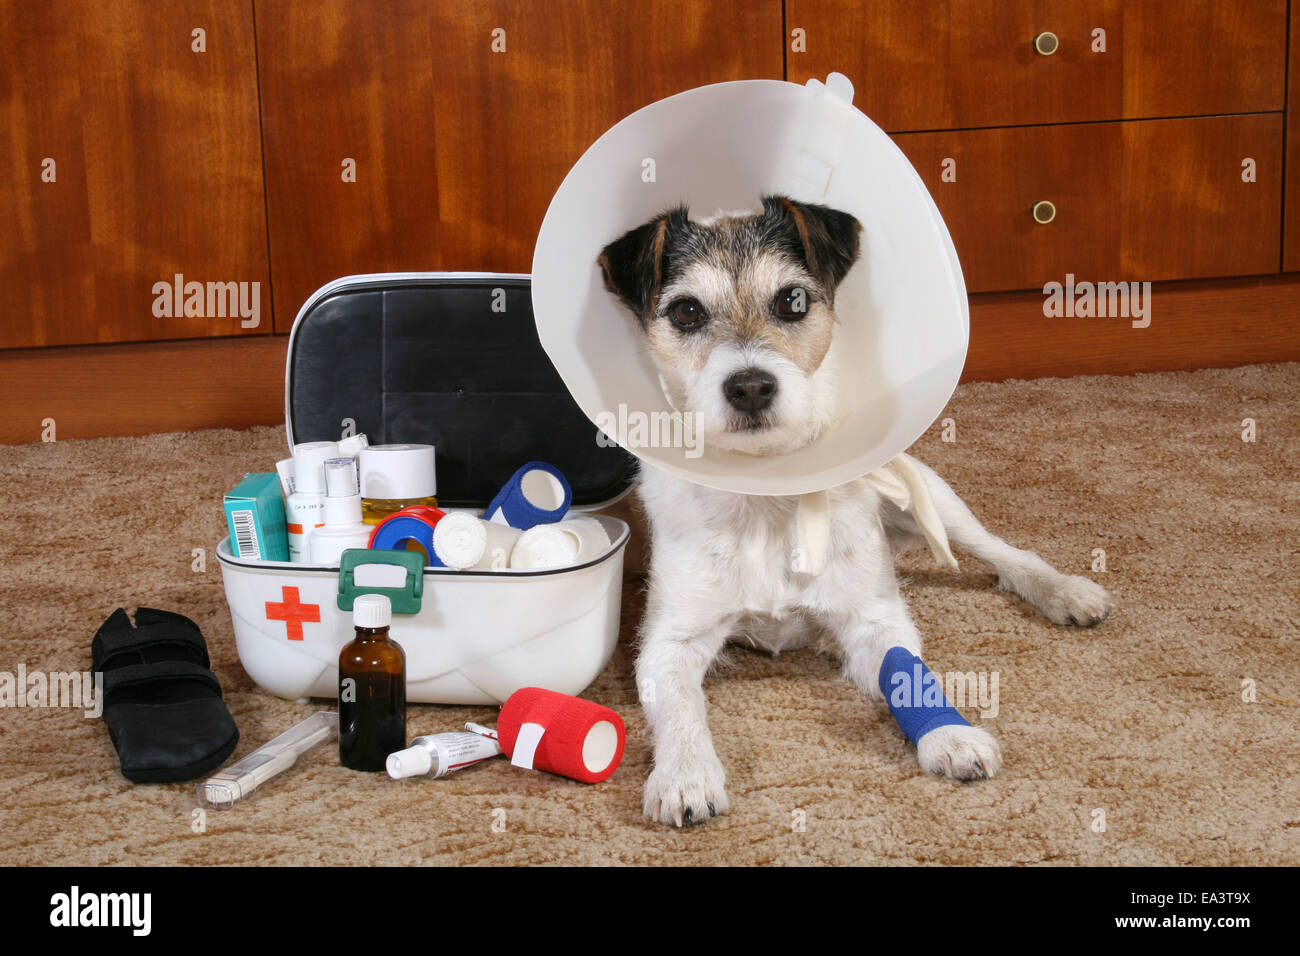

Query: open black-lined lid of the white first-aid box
[{"left": 292, "top": 273, "right": 636, "bottom": 507}]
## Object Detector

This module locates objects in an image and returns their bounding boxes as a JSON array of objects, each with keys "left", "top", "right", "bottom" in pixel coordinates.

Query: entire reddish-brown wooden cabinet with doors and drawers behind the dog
[{"left": 0, "top": 0, "right": 1300, "bottom": 441}]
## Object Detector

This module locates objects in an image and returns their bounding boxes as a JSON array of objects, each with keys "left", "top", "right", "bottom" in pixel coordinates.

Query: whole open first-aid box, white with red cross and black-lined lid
[{"left": 217, "top": 273, "right": 633, "bottom": 704}]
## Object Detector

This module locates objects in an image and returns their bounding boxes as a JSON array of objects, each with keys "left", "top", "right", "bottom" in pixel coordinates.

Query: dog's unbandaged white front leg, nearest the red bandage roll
[{"left": 637, "top": 593, "right": 733, "bottom": 827}]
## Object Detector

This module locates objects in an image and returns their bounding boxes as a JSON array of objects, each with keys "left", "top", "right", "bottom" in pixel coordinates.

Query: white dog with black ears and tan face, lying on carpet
[{"left": 598, "top": 196, "right": 1112, "bottom": 826}]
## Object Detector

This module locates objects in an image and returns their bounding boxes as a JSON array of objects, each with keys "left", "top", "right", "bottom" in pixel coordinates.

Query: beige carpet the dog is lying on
[{"left": 0, "top": 364, "right": 1300, "bottom": 865}]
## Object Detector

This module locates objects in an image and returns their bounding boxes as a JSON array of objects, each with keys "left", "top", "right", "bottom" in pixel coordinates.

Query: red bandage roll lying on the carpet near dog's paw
[{"left": 497, "top": 687, "right": 628, "bottom": 783}]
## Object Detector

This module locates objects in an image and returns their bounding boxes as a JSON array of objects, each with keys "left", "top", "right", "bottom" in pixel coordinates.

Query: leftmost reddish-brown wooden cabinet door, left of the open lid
[{"left": 0, "top": 0, "right": 270, "bottom": 347}]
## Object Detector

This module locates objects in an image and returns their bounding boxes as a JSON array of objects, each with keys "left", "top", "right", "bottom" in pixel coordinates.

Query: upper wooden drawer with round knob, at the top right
[{"left": 787, "top": 0, "right": 1287, "bottom": 131}]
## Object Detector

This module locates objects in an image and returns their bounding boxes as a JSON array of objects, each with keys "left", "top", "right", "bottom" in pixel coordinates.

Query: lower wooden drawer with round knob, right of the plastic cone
[{"left": 894, "top": 113, "right": 1282, "bottom": 291}]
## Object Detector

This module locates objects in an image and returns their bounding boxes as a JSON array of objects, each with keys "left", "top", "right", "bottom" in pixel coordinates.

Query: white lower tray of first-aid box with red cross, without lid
[{"left": 217, "top": 515, "right": 628, "bottom": 704}]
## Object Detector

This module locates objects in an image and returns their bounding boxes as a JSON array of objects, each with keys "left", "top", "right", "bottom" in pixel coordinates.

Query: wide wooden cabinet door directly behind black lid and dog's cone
[{"left": 256, "top": 0, "right": 783, "bottom": 330}]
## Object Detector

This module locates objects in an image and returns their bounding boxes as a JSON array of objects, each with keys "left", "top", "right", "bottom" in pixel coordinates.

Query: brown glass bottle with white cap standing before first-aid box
[{"left": 338, "top": 594, "right": 406, "bottom": 771}]
